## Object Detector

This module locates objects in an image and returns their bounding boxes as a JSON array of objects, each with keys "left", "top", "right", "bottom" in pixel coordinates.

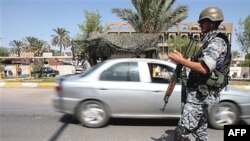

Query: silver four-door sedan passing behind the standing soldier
[{"left": 53, "top": 58, "right": 250, "bottom": 129}]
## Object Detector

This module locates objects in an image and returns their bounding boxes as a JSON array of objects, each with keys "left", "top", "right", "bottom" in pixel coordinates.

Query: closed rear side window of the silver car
[{"left": 100, "top": 62, "right": 140, "bottom": 82}]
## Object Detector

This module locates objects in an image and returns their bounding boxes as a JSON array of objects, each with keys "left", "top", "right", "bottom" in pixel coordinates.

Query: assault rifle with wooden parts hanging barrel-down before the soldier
[{"left": 160, "top": 36, "right": 198, "bottom": 112}]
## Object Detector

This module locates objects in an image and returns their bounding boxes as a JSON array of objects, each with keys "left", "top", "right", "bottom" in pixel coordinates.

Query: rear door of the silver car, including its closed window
[{"left": 95, "top": 61, "right": 151, "bottom": 116}]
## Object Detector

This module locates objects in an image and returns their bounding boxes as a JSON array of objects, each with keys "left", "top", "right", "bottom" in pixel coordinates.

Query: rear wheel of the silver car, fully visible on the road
[{"left": 76, "top": 100, "right": 110, "bottom": 128}]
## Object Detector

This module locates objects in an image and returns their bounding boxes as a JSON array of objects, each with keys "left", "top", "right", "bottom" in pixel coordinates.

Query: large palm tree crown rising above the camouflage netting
[{"left": 112, "top": 0, "right": 187, "bottom": 33}]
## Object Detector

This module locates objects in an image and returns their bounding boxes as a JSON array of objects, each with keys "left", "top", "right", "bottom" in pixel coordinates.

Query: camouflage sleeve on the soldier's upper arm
[{"left": 200, "top": 37, "right": 227, "bottom": 71}]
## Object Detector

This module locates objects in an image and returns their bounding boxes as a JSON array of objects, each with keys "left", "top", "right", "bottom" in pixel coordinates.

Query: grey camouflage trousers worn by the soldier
[{"left": 175, "top": 91, "right": 214, "bottom": 141}]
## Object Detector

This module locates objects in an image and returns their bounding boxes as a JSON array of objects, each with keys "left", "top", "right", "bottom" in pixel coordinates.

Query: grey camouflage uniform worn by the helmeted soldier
[{"left": 175, "top": 31, "right": 227, "bottom": 141}]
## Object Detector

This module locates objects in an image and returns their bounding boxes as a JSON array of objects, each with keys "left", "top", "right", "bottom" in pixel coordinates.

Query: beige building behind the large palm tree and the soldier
[{"left": 105, "top": 22, "right": 233, "bottom": 59}]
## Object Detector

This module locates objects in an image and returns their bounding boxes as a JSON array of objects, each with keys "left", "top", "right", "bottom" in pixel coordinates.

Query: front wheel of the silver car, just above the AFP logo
[{"left": 208, "top": 102, "right": 240, "bottom": 130}]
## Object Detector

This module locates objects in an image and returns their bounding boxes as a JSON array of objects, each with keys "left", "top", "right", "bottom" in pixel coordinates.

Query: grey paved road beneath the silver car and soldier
[{"left": 0, "top": 88, "right": 226, "bottom": 141}]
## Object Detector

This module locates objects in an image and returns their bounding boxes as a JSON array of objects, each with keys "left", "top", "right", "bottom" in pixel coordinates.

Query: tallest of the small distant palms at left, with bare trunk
[{"left": 51, "top": 27, "right": 71, "bottom": 55}]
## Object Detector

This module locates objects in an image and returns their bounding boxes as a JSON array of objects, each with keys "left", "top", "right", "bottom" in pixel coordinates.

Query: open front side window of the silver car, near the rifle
[{"left": 148, "top": 63, "right": 174, "bottom": 83}]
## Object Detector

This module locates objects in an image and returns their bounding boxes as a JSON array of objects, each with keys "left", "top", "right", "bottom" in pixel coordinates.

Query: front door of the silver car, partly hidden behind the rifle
[{"left": 143, "top": 62, "right": 181, "bottom": 117}]
